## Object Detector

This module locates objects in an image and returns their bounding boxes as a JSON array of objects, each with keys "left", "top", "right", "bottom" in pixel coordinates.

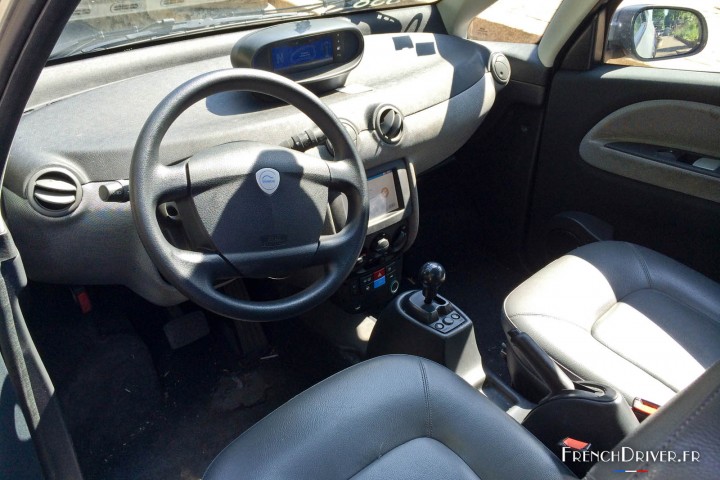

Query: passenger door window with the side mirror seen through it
[{"left": 603, "top": 0, "right": 720, "bottom": 72}]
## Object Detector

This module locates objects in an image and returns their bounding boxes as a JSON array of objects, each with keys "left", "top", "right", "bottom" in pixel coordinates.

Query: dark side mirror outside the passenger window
[{"left": 606, "top": 5, "right": 708, "bottom": 62}]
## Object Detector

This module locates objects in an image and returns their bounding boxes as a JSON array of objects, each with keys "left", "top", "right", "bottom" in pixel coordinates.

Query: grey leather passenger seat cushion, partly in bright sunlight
[{"left": 503, "top": 242, "right": 720, "bottom": 404}]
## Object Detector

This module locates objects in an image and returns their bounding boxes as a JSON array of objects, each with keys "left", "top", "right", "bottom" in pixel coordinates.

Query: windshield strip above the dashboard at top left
[{"left": 50, "top": 0, "right": 434, "bottom": 60}]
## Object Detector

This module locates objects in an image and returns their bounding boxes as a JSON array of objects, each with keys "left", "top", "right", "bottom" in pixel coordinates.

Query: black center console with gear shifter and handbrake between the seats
[{"left": 367, "top": 262, "right": 638, "bottom": 477}]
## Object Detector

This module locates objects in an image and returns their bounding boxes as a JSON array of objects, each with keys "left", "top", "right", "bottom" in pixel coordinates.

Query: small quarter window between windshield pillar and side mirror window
[{"left": 467, "top": 0, "right": 562, "bottom": 43}]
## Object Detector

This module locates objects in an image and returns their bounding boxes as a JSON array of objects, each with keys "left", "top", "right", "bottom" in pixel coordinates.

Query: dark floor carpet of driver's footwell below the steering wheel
[{"left": 22, "top": 284, "right": 324, "bottom": 480}]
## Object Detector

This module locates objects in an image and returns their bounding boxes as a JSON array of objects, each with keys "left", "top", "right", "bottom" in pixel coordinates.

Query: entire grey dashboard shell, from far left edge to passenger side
[{"left": 5, "top": 29, "right": 497, "bottom": 304}]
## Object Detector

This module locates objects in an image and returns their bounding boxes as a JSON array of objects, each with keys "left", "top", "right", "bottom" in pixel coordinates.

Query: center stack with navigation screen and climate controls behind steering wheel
[{"left": 332, "top": 161, "right": 418, "bottom": 313}]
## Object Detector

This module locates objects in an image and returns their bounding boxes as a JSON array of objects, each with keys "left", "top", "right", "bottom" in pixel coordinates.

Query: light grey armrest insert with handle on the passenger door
[{"left": 580, "top": 100, "right": 720, "bottom": 203}]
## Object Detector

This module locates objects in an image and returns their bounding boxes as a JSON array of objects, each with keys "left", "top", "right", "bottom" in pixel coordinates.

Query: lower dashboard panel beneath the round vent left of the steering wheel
[{"left": 3, "top": 183, "right": 184, "bottom": 305}]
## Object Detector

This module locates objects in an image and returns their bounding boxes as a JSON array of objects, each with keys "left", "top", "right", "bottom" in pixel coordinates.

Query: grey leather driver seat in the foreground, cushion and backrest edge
[{"left": 204, "top": 355, "right": 720, "bottom": 480}]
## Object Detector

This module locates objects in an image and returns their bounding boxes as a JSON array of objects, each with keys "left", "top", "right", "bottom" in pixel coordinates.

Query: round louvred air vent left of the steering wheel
[{"left": 28, "top": 167, "right": 82, "bottom": 217}]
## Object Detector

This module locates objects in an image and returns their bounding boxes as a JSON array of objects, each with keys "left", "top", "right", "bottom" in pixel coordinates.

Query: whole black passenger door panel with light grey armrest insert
[{"left": 527, "top": 66, "right": 720, "bottom": 279}]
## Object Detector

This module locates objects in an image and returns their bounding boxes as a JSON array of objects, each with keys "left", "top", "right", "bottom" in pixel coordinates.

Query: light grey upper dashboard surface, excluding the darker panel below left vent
[{"left": 14, "top": 34, "right": 486, "bottom": 194}]
